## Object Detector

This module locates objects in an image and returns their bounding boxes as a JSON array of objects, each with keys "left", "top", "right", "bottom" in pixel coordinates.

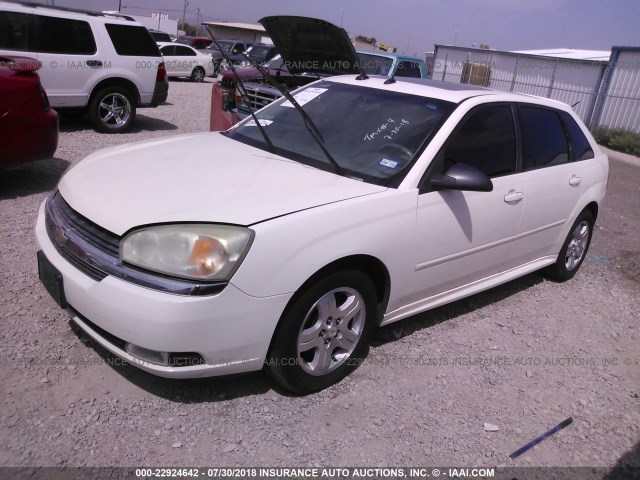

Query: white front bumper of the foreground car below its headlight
[{"left": 36, "top": 203, "right": 291, "bottom": 378}]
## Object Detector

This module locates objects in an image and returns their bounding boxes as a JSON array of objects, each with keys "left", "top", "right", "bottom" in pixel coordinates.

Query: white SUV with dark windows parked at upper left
[{"left": 0, "top": 2, "right": 169, "bottom": 133}]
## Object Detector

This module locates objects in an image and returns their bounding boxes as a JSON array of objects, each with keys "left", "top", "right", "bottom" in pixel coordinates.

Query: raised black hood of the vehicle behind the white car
[{"left": 259, "top": 16, "right": 360, "bottom": 75}]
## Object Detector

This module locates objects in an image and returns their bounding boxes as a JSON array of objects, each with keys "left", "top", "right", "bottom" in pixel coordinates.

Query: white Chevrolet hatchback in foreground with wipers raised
[{"left": 36, "top": 17, "right": 608, "bottom": 392}]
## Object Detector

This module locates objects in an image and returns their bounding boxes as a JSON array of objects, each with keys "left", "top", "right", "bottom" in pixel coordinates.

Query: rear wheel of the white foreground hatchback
[{"left": 543, "top": 210, "right": 595, "bottom": 282}]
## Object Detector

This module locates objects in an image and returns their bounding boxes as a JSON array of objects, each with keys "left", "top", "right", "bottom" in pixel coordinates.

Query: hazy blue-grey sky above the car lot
[{"left": 28, "top": 0, "right": 640, "bottom": 56}]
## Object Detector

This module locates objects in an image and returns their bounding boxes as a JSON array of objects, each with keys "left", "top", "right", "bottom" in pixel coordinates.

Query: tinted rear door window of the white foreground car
[{"left": 520, "top": 107, "right": 569, "bottom": 170}]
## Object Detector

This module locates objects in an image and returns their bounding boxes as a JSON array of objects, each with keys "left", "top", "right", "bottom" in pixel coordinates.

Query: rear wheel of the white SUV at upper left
[{"left": 89, "top": 87, "right": 136, "bottom": 133}]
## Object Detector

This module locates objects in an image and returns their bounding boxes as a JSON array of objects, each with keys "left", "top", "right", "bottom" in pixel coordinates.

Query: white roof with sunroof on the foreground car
[{"left": 323, "top": 75, "right": 571, "bottom": 111}]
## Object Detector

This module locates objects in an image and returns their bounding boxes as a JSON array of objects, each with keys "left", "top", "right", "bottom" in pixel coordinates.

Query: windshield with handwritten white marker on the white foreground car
[{"left": 228, "top": 80, "right": 455, "bottom": 186}]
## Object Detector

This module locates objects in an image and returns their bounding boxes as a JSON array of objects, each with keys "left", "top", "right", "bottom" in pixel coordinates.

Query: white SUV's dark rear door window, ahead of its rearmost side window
[{"left": 33, "top": 15, "right": 96, "bottom": 55}]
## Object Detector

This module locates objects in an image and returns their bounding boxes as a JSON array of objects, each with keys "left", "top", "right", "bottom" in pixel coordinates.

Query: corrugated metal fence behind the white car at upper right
[{"left": 432, "top": 46, "right": 640, "bottom": 133}]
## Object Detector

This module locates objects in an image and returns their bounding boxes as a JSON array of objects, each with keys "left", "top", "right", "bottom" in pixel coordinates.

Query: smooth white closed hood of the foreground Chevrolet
[{"left": 58, "top": 132, "right": 386, "bottom": 235}]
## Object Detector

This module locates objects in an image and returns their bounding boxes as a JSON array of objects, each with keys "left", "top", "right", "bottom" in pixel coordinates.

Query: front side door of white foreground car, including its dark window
[{"left": 405, "top": 104, "right": 524, "bottom": 303}]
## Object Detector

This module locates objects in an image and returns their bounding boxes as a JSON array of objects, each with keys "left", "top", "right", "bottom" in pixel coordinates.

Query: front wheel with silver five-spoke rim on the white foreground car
[{"left": 267, "top": 270, "right": 376, "bottom": 393}]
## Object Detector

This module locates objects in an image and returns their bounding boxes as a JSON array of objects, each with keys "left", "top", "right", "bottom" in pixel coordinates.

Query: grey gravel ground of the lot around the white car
[{"left": 0, "top": 82, "right": 640, "bottom": 474}]
